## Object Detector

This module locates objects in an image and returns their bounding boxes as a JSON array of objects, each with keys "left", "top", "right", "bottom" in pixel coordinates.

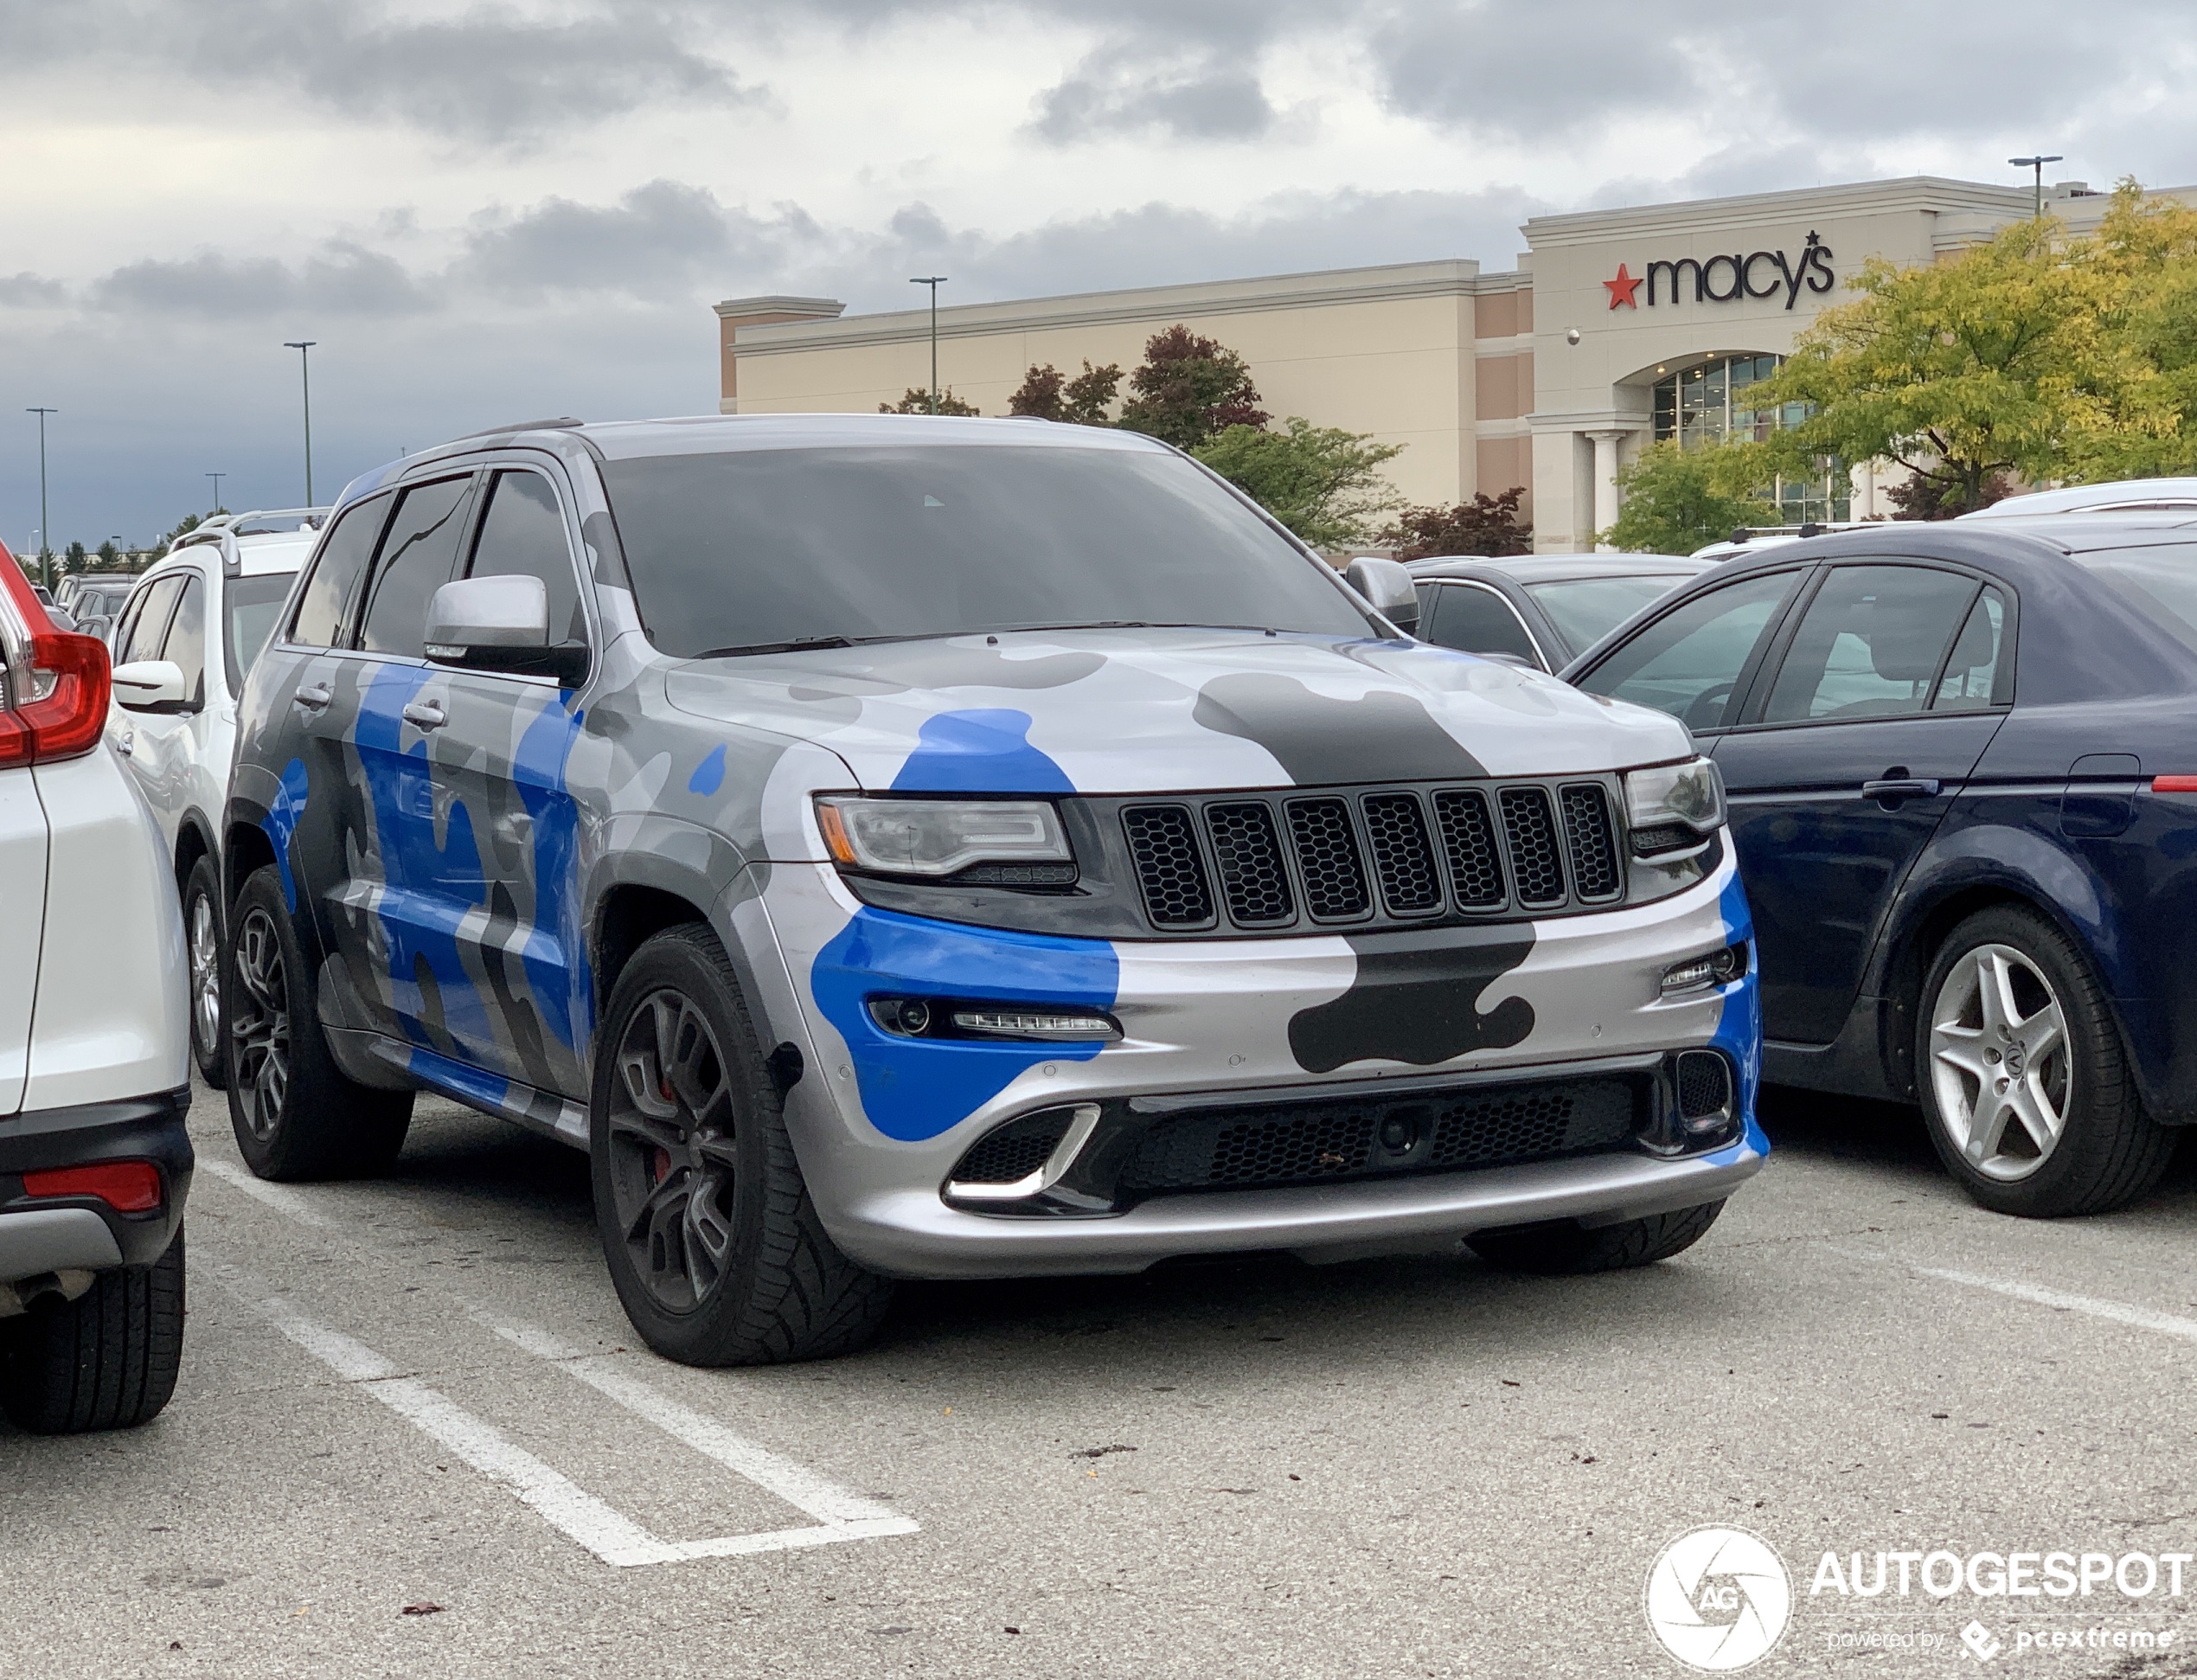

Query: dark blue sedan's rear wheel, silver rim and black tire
[{"left": 1916, "top": 905, "right": 2175, "bottom": 1219}]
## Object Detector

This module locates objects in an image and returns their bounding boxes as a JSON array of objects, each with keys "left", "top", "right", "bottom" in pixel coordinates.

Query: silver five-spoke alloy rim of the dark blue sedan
[{"left": 1929, "top": 945, "right": 2076, "bottom": 1183}]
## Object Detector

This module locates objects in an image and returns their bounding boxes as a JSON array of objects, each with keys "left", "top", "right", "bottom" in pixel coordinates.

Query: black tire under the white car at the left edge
[{"left": 0, "top": 1226, "right": 183, "bottom": 1434}]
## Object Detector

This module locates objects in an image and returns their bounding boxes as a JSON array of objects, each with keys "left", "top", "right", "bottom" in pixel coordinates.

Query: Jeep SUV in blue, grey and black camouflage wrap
[{"left": 224, "top": 415, "right": 1765, "bottom": 1363}]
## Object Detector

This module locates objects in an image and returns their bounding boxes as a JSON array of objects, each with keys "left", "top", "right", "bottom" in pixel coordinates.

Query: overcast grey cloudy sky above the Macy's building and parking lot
[{"left": 0, "top": 0, "right": 2197, "bottom": 547}]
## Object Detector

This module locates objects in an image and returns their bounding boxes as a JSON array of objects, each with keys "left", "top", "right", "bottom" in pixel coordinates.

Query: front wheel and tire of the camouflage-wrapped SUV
[{"left": 589, "top": 922, "right": 892, "bottom": 1366}]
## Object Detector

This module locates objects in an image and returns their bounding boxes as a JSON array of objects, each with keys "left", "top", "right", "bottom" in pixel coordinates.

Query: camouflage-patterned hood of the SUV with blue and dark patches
[{"left": 666, "top": 631, "right": 1694, "bottom": 792}]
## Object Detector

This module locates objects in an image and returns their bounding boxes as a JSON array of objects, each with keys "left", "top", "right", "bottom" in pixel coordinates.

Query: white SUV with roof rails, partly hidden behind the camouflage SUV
[{"left": 106, "top": 510, "right": 312, "bottom": 1087}]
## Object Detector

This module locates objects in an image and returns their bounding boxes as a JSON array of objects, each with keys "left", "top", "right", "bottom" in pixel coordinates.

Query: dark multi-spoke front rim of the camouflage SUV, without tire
[{"left": 609, "top": 986, "right": 738, "bottom": 1313}]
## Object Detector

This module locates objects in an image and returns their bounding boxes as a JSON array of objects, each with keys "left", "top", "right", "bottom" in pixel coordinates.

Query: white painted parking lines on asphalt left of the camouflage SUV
[{"left": 184, "top": 1159, "right": 923, "bottom": 1568}]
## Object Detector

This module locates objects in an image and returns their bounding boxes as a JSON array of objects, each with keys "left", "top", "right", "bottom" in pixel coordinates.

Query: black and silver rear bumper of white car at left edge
[{"left": 0, "top": 1087, "right": 195, "bottom": 1285}]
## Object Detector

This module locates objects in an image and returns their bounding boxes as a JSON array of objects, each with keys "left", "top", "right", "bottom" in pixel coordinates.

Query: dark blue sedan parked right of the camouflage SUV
[{"left": 1566, "top": 514, "right": 2197, "bottom": 1215}]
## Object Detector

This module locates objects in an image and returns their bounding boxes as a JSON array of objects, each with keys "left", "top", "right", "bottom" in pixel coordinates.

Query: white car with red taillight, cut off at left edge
[{"left": 0, "top": 549, "right": 191, "bottom": 1432}]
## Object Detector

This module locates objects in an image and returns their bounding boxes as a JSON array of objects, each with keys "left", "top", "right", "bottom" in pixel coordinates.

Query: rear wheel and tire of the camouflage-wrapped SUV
[{"left": 222, "top": 863, "right": 413, "bottom": 1179}]
